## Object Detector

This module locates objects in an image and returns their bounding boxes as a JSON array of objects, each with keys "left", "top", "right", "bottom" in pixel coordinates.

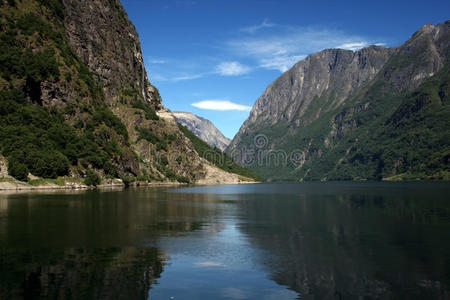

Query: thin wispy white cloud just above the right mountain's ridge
[{"left": 225, "top": 23, "right": 384, "bottom": 72}]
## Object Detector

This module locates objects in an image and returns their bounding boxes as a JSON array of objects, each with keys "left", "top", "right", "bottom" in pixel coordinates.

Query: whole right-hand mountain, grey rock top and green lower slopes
[{"left": 226, "top": 21, "right": 450, "bottom": 180}]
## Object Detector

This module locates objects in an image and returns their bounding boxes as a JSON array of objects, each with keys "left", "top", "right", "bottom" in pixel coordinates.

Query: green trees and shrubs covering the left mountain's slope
[{"left": 0, "top": 4, "right": 134, "bottom": 181}]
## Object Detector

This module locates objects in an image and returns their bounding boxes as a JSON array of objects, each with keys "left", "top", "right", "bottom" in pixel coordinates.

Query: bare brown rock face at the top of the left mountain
[{"left": 63, "top": 0, "right": 161, "bottom": 108}]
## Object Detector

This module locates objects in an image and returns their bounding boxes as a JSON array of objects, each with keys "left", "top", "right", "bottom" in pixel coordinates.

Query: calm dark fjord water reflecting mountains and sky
[{"left": 0, "top": 183, "right": 450, "bottom": 300}]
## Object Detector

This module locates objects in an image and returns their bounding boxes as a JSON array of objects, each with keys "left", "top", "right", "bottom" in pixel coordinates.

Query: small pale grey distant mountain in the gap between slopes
[{"left": 173, "top": 111, "right": 231, "bottom": 151}]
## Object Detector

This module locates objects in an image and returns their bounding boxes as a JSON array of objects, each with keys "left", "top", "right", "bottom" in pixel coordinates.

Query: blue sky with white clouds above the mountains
[{"left": 122, "top": 0, "right": 450, "bottom": 138}]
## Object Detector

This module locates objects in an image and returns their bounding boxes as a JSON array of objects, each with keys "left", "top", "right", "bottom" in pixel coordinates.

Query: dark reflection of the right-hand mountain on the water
[{"left": 234, "top": 185, "right": 450, "bottom": 299}]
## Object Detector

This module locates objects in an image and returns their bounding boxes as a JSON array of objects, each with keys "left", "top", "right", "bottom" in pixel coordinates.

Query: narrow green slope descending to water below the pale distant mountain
[{"left": 178, "top": 124, "right": 261, "bottom": 181}]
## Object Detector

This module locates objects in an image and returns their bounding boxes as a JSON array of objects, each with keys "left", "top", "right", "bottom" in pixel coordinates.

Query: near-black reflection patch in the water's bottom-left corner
[{"left": 0, "top": 247, "right": 163, "bottom": 299}]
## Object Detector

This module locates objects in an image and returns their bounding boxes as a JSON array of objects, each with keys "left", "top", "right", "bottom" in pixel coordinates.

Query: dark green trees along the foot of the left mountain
[{"left": 0, "top": 90, "right": 128, "bottom": 178}]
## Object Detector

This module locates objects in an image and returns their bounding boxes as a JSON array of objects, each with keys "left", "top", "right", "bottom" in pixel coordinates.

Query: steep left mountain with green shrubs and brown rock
[{"left": 0, "top": 0, "right": 253, "bottom": 182}]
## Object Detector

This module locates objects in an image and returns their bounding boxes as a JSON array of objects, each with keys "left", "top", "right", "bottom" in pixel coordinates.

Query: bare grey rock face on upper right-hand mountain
[{"left": 227, "top": 46, "right": 395, "bottom": 157}]
